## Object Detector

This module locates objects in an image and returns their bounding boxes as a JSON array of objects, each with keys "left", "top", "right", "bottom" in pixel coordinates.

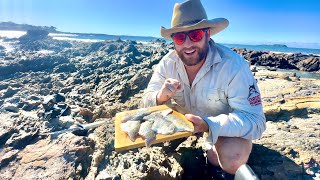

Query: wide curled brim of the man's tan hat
[{"left": 160, "top": 18, "right": 229, "bottom": 39}]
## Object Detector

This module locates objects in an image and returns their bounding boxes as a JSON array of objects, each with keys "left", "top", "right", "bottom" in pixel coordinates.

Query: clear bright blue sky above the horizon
[{"left": 0, "top": 0, "right": 320, "bottom": 48}]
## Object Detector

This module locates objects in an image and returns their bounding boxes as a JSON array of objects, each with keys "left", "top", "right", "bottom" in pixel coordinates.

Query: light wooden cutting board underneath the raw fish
[{"left": 114, "top": 105, "right": 193, "bottom": 152}]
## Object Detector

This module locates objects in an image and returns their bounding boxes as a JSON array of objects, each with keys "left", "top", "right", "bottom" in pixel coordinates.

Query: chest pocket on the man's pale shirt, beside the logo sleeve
[{"left": 207, "top": 89, "right": 230, "bottom": 115}]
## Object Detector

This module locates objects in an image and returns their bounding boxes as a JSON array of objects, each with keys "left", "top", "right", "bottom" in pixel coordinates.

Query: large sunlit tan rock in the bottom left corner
[{"left": 0, "top": 134, "right": 93, "bottom": 179}]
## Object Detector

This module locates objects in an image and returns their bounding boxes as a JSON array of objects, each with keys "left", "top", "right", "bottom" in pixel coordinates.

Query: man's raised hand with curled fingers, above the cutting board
[{"left": 157, "top": 78, "right": 181, "bottom": 105}]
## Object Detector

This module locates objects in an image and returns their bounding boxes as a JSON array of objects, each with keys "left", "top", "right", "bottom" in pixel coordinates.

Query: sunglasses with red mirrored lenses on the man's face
[{"left": 171, "top": 28, "right": 208, "bottom": 45}]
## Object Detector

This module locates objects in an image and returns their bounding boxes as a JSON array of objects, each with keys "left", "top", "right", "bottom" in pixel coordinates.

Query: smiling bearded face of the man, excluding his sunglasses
[{"left": 174, "top": 30, "right": 210, "bottom": 66}]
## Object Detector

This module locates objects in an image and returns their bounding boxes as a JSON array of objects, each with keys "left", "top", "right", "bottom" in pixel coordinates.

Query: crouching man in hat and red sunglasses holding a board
[{"left": 143, "top": 0, "right": 266, "bottom": 177}]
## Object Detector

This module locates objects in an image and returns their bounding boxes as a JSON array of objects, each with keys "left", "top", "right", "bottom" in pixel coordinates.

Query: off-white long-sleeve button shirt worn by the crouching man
[{"left": 143, "top": 40, "right": 266, "bottom": 144}]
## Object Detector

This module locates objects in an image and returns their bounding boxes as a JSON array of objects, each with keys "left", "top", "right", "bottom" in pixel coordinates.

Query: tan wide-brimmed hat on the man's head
[{"left": 160, "top": 0, "right": 229, "bottom": 39}]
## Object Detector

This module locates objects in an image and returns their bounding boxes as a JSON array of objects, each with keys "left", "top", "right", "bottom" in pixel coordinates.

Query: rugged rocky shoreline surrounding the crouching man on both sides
[{"left": 0, "top": 33, "right": 320, "bottom": 179}]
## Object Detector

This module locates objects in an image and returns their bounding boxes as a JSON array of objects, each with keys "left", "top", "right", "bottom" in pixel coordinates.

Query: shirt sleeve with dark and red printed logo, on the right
[{"left": 203, "top": 64, "right": 266, "bottom": 144}]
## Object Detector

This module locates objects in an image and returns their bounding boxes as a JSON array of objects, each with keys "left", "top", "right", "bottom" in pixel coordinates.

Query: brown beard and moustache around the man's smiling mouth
[{"left": 176, "top": 43, "right": 209, "bottom": 66}]
